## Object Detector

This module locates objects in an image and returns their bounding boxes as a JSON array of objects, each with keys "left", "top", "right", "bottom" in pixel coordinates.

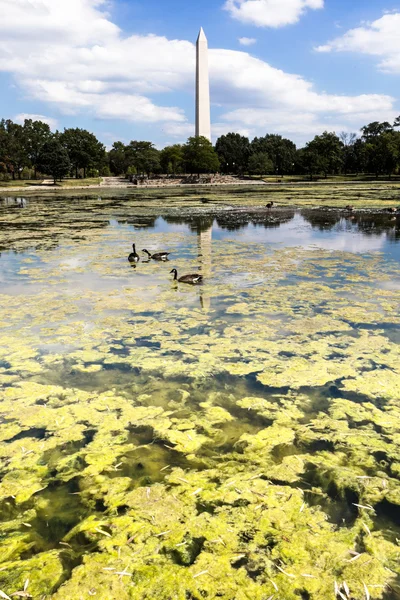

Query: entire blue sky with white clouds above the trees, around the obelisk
[{"left": 0, "top": 0, "right": 400, "bottom": 147}]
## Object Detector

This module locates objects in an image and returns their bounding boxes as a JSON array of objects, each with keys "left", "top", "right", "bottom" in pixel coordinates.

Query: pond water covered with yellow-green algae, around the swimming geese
[{"left": 0, "top": 195, "right": 400, "bottom": 600}]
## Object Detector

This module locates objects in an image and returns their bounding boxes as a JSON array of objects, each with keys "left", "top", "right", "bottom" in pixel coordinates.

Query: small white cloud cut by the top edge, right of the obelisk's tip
[{"left": 224, "top": 0, "right": 324, "bottom": 27}]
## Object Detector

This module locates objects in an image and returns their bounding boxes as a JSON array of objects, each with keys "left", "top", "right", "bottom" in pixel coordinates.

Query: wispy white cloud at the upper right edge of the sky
[{"left": 316, "top": 12, "right": 400, "bottom": 73}]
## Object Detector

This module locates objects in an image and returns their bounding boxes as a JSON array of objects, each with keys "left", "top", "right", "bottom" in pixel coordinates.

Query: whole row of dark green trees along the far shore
[{"left": 0, "top": 116, "right": 400, "bottom": 181}]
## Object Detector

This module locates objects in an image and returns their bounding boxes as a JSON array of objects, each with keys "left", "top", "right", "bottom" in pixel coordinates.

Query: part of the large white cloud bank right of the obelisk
[{"left": 210, "top": 50, "right": 398, "bottom": 143}]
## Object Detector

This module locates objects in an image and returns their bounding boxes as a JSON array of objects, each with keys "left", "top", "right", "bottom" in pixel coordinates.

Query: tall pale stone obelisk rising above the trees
[{"left": 196, "top": 28, "right": 211, "bottom": 141}]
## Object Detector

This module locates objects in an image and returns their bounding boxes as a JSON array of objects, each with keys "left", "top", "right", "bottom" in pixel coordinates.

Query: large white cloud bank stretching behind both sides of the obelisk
[{"left": 0, "top": 0, "right": 398, "bottom": 141}]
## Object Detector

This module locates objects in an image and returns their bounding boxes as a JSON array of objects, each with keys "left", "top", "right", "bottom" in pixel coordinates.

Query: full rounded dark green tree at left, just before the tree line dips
[{"left": 60, "top": 128, "right": 105, "bottom": 177}]
